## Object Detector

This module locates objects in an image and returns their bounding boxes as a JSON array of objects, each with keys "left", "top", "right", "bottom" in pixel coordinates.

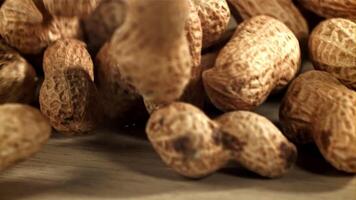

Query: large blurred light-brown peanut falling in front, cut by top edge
[{"left": 111, "top": 0, "right": 192, "bottom": 103}]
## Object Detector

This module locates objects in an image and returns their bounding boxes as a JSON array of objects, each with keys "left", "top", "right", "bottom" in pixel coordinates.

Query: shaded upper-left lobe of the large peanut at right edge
[{"left": 280, "top": 71, "right": 354, "bottom": 143}]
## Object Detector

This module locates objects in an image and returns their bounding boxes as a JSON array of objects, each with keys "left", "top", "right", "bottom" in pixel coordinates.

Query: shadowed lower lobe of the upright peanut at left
[{"left": 39, "top": 68, "right": 101, "bottom": 135}]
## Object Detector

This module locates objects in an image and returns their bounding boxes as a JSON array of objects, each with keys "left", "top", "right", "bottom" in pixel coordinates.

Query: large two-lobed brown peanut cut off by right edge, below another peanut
[{"left": 280, "top": 71, "right": 356, "bottom": 173}]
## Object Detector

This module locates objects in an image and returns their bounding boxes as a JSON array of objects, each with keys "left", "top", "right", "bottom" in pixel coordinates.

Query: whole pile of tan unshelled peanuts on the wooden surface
[{"left": 0, "top": 0, "right": 356, "bottom": 178}]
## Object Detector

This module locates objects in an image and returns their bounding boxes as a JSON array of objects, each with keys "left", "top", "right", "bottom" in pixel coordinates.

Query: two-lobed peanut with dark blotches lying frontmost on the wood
[{"left": 146, "top": 103, "right": 297, "bottom": 178}]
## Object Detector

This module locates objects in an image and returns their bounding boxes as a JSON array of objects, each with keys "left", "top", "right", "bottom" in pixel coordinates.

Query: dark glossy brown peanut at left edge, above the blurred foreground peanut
[{"left": 0, "top": 46, "right": 37, "bottom": 104}]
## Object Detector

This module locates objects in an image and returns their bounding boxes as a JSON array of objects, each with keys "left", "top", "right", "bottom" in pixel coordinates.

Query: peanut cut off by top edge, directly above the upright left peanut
[{"left": 43, "top": 0, "right": 101, "bottom": 17}]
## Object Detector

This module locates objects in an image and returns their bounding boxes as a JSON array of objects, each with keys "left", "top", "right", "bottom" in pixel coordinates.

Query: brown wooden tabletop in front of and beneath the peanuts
[{"left": 0, "top": 63, "right": 356, "bottom": 200}]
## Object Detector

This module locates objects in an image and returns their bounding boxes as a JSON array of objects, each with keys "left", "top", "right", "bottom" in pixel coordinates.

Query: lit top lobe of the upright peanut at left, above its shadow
[{"left": 43, "top": 39, "right": 94, "bottom": 80}]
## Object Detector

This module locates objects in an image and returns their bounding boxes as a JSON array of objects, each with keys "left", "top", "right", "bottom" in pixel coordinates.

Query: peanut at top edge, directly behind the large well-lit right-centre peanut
[{"left": 229, "top": 0, "right": 309, "bottom": 40}]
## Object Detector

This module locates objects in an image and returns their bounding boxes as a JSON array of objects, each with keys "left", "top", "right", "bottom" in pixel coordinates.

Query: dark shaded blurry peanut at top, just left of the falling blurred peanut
[{"left": 84, "top": 0, "right": 125, "bottom": 54}]
